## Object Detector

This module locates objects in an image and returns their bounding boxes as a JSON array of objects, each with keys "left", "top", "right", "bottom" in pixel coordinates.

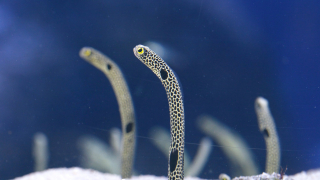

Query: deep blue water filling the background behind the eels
[{"left": 0, "top": 0, "right": 320, "bottom": 179}]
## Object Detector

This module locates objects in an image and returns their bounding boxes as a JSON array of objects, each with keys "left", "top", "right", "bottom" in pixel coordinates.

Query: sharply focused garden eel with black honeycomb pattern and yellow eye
[{"left": 133, "top": 45, "right": 184, "bottom": 180}]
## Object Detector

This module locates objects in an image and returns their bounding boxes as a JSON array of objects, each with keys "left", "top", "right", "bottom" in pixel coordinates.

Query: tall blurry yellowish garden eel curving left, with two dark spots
[{"left": 79, "top": 47, "right": 136, "bottom": 179}]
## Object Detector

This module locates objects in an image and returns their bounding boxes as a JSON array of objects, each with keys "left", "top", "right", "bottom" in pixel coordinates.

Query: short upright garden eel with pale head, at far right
[{"left": 255, "top": 97, "right": 280, "bottom": 174}]
